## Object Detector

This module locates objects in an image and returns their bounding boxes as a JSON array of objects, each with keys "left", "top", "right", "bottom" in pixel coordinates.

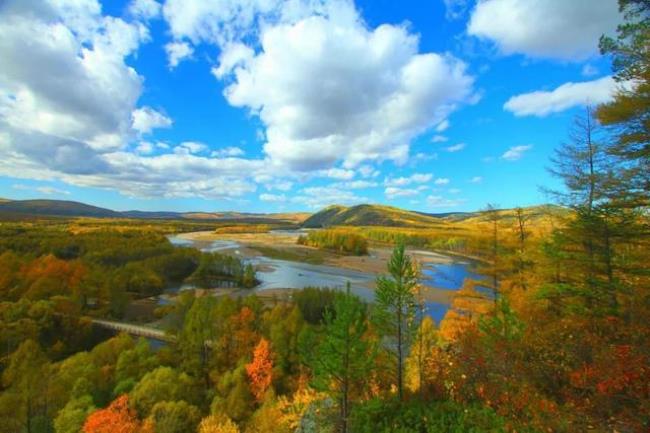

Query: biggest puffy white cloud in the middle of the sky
[{"left": 215, "top": 2, "right": 473, "bottom": 170}]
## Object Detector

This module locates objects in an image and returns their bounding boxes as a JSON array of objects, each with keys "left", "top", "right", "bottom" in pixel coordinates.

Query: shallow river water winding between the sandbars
[{"left": 168, "top": 232, "right": 480, "bottom": 323}]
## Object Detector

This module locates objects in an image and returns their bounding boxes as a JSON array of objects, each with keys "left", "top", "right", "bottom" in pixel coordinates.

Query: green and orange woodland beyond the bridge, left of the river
[{"left": 0, "top": 221, "right": 256, "bottom": 317}]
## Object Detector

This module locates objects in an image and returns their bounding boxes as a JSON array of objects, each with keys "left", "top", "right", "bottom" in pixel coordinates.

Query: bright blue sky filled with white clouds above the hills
[{"left": 0, "top": 0, "right": 620, "bottom": 212}]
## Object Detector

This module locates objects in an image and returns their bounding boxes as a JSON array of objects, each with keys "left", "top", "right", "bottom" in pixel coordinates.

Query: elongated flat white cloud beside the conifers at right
[{"left": 503, "top": 76, "right": 620, "bottom": 117}]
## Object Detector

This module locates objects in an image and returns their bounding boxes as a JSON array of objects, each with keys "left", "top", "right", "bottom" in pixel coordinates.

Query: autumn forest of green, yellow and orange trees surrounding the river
[{"left": 0, "top": 1, "right": 650, "bottom": 433}]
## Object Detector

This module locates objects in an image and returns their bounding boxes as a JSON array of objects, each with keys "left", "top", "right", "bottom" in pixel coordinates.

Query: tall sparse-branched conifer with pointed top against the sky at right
[{"left": 547, "top": 107, "right": 630, "bottom": 312}]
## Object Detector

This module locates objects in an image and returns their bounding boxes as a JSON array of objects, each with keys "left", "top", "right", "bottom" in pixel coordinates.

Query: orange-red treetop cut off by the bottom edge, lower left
[{"left": 83, "top": 394, "right": 140, "bottom": 433}]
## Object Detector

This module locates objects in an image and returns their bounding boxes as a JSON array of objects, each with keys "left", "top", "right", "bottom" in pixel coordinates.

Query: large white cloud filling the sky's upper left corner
[{"left": 0, "top": 0, "right": 149, "bottom": 155}]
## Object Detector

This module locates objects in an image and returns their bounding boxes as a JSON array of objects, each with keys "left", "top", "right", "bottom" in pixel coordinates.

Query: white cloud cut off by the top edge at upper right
[{"left": 467, "top": 0, "right": 621, "bottom": 61}]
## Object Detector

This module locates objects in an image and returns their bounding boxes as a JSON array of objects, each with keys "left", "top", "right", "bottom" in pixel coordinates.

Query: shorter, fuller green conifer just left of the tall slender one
[{"left": 308, "top": 283, "right": 374, "bottom": 433}]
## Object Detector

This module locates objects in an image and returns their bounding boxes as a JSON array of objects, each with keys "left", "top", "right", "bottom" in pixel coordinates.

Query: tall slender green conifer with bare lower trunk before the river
[{"left": 375, "top": 243, "right": 418, "bottom": 400}]
